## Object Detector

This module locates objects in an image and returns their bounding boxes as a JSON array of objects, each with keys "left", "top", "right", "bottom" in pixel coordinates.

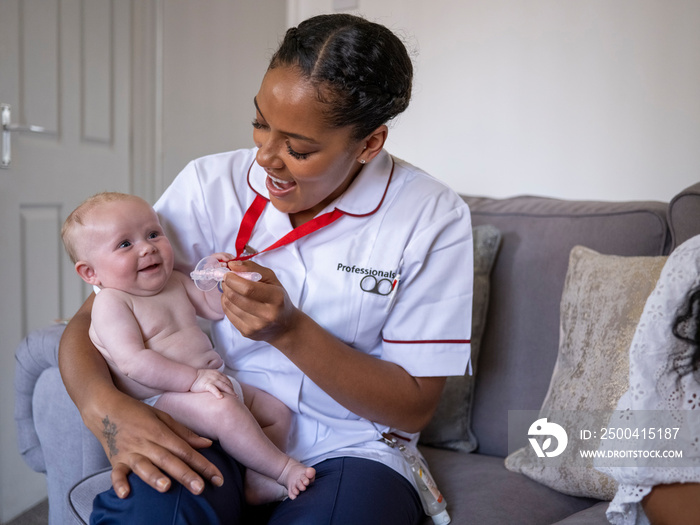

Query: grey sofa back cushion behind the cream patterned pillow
[{"left": 465, "top": 197, "right": 670, "bottom": 457}]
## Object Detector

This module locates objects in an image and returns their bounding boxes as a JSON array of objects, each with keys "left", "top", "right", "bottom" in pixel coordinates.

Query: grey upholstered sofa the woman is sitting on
[{"left": 16, "top": 183, "right": 700, "bottom": 525}]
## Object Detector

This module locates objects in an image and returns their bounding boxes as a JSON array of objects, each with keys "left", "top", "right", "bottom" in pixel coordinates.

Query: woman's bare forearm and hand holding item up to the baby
[{"left": 223, "top": 262, "right": 445, "bottom": 432}]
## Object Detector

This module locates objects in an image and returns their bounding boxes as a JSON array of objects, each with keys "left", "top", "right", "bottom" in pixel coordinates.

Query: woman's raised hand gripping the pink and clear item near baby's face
[{"left": 221, "top": 261, "right": 300, "bottom": 346}]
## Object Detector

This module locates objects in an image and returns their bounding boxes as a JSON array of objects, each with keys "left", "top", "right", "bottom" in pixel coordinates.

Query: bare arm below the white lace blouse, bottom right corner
[{"left": 642, "top": 483, "right": 700, "bottom": 525}]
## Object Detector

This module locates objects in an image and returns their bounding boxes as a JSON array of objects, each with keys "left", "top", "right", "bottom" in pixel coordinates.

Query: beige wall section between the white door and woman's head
[{"left": 156, "top": 0, "right": 285, "bottom": 192}]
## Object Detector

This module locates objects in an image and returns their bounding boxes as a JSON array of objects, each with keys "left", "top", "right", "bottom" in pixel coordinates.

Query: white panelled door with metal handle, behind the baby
[{"left": 0, "top": 0, "right": 131, "bottom": 523}]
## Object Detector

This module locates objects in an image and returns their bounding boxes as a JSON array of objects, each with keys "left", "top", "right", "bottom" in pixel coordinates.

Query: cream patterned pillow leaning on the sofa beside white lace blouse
[{"left": 505, "top": 246, "right": 667, "bottom": 500}]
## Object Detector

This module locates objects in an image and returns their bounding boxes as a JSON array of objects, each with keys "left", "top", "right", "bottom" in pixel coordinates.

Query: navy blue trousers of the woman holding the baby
[{"left": 90, "top": 443, "right": 423, "bottom": 525}]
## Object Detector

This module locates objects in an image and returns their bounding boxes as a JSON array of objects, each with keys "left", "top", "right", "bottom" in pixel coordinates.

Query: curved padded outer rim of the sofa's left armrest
[{"left": 15, "top": 324, "right": 65, "bottom": 472}]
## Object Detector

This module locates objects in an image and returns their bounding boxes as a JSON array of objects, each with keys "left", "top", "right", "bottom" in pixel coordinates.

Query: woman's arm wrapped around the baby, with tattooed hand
[{"left": 58, "top": 296, "right": 223, "bottom": 498}]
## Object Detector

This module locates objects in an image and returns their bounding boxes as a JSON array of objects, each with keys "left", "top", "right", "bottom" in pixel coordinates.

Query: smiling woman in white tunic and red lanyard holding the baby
[{"left": 60, "top": 15, "right": 472, "bottom": 524}]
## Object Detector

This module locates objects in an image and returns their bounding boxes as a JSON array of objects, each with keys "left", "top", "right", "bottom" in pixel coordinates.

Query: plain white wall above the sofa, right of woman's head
[{"left": 287, "top": 0, "right": 700, "bottom": 200}]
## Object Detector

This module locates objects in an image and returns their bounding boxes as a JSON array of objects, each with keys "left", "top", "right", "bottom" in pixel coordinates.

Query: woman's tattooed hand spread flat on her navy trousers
[{"left": 84, "top": 393, "right": 223, "bottom": 498}]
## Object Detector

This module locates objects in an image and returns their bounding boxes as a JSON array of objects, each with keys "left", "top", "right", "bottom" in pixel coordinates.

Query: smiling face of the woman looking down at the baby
[{"left": 253, "top": 67, "right": 363, "bottom": 226}]
